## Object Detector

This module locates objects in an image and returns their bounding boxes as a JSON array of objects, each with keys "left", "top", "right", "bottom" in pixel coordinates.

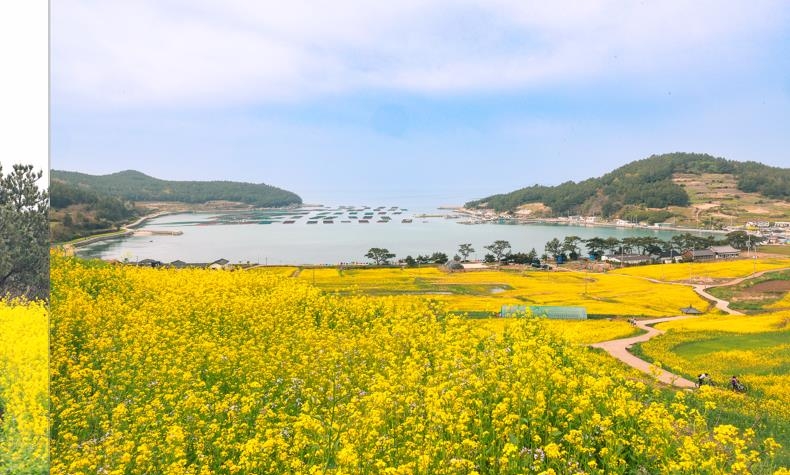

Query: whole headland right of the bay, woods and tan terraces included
[{"left": 464, "top": 152, "right": 790, "bottom": 228}]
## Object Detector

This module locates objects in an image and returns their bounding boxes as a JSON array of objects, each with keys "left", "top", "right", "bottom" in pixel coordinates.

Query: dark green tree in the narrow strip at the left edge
[{"left": 0, "top": 165, "right": 49, "bottom": 299}]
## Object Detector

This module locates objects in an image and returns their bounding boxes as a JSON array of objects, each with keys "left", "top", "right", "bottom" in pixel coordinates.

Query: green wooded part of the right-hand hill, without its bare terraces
[{"left": 465, "top": 152, "right": 790, "bottom": 220}]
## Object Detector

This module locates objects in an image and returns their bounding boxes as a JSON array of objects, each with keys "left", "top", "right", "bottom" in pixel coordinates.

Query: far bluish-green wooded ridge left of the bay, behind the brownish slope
[{"left": 51, "top": 170, "right": 302, "bottom": 207}]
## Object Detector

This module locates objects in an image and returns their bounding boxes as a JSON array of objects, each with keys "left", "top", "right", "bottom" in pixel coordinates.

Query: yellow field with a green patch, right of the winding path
[{"left": 640, "top": 311, "right": 790, "bottom": 465}]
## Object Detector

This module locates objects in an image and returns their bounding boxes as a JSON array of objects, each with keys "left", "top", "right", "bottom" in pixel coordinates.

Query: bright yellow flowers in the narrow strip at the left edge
[{"left": 0, "top": 300, "right": 49, "bottom": 474}]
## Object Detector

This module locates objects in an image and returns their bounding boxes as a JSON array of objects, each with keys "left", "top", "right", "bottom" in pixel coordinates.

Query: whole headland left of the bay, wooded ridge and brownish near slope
[{"left": 49, "top": 170, "right": 302, "bottom": 242}]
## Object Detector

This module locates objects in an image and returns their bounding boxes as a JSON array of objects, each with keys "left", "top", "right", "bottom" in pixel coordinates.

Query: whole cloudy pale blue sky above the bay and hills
[{"left": 50, "top": 0, "right": 790, "bottom": 205}]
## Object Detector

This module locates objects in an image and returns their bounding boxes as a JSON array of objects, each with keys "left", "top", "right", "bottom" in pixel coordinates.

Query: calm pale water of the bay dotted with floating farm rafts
[{"left": 79, "top": 207, "right": 712, "bottom": 265}]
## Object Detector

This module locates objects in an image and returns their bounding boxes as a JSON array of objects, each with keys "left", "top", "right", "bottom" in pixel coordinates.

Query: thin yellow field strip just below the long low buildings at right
[{"left": 611, "top": 257, "right": 790, "bottom": 282}]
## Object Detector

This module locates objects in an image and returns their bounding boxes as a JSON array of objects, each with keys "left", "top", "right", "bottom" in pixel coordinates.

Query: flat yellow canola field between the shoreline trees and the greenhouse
[{"left": 299, "top": 267, "right": 708, "bottom": 316}]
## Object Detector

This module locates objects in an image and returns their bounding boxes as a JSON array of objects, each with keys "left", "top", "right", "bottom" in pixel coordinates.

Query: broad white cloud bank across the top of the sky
[{"left": 52, "top": 0, "right": 788, "bottom": 106}]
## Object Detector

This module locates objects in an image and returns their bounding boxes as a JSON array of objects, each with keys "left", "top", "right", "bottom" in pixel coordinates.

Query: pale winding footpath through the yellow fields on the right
[{"left": 590, "top": 267, "right": 790, "bottom": 388}]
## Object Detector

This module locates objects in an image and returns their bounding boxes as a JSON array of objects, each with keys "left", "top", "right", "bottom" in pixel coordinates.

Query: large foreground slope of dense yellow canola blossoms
[{"left": 51, "top": 256, "right": 780, "bottom": 475}]
